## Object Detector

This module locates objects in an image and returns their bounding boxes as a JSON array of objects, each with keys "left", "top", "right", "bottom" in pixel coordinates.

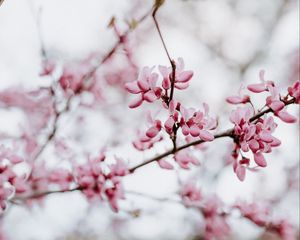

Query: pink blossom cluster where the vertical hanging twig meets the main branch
[{"left": 133, "top": 97, "right": 217, "bottom": 169}]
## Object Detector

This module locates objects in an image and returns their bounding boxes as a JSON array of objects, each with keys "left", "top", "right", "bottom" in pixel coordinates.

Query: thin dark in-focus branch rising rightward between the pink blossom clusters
[{"left": 129, "top": 98, "right": 295, "bottom": 173}]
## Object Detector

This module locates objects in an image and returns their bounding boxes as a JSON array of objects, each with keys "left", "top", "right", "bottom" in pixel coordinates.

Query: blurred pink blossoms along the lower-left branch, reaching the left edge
[{"left": 0, "top": 146, "right": 129, "bottom": 214}]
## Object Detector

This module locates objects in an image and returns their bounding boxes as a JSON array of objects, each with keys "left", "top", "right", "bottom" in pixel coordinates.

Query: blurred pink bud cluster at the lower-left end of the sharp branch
[{"left": 75, "top": 153, "right": 128, "bottom": 212}]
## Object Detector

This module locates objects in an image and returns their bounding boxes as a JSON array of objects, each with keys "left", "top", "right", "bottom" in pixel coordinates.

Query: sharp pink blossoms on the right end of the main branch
[{"left": 226, "top": 71, "right": 299, "bottom": 181}]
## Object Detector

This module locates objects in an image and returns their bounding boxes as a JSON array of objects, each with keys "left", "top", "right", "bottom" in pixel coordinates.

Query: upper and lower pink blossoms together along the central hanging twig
[{"left": 125, "top": 58, "right": 217, "bottom": 164}]
